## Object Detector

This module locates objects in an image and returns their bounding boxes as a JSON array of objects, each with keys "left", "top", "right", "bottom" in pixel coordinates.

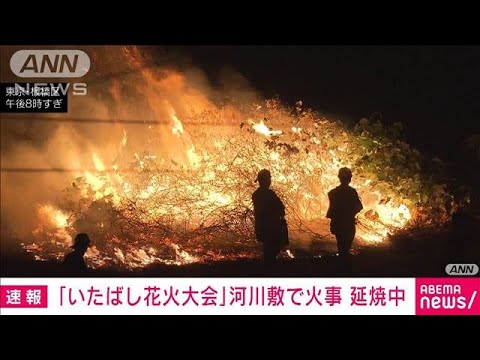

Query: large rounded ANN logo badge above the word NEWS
[{"left": 10, "top": 50, "right": 90, "bottom": 78}]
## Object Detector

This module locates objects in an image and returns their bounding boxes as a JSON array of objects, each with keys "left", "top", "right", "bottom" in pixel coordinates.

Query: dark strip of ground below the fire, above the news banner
[{"left": 1, "top": 222, "right": 480, "bottom": 277}]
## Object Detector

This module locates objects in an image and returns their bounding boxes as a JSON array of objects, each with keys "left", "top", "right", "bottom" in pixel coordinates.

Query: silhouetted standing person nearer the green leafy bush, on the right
[{"left": 327, "top": 167, "right": 363, "bottom": 262}]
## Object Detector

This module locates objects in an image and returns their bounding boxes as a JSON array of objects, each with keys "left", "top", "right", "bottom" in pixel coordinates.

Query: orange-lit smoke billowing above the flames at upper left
[{"left": 0, "top": 46, "right": 260, "bottom": 250}]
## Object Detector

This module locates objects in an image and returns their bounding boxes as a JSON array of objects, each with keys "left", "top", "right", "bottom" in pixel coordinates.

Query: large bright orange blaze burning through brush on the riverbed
[{"left": 20, "top": 45, "right": 426, "bottom": 268}]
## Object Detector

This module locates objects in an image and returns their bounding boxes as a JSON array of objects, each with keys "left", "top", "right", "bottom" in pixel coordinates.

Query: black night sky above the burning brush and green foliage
[{"left": 174, "top": 46, "right": 480, "bottom": 158}]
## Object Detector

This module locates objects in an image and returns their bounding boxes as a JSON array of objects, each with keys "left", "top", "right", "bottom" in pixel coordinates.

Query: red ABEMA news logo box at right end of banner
[{"left": 415, "top": 278, "right": 480, "bottom": 315}]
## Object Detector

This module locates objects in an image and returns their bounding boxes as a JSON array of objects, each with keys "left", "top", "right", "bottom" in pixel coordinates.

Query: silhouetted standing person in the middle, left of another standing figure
[{"left": 252, "top": 169, "right": 285, "bottom": 263}]
